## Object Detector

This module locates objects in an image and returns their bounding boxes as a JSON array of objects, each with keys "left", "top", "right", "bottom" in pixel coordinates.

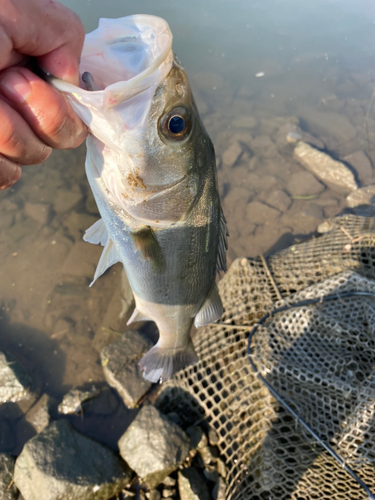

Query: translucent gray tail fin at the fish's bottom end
[{"left": 139, "top": 341, "right": 199, "bottom": 383}]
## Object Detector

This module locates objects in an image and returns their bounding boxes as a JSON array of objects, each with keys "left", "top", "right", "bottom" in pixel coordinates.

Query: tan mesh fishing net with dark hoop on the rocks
[{"left": 157, "top": 215, "right": 375, "bottom": 500}]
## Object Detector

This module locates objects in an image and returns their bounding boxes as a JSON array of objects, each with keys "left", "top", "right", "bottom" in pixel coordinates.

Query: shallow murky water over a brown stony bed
[{"left": 0, "top": 0, "right": 375, "bottom": 453}]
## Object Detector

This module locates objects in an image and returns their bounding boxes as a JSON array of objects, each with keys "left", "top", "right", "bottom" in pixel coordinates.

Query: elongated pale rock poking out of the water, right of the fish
[{"left": 294, "top": 142, "right": 358, "bottom": 190}]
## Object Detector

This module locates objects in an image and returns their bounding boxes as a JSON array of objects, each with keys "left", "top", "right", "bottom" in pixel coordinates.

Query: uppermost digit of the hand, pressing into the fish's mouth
[{"left": 0, "top": 0, "right": 85, "bottom": 85}]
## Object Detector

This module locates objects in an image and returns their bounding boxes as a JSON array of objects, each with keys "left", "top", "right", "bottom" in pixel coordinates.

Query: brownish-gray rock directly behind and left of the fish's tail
[{"left": 100, "top": 330, "right": 152, "bottom": 408}]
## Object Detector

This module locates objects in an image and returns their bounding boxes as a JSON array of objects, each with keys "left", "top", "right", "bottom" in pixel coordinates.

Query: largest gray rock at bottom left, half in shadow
[{"left": 14, "top": 420, "right": 131, "bottom": 500}]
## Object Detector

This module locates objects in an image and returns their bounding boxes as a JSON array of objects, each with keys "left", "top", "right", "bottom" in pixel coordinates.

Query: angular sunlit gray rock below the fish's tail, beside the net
[{"left": 118, "top": 406, "right": 191, "bottom": 488}]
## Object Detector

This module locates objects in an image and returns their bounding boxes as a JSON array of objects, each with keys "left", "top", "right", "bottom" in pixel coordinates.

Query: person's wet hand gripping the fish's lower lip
[{"left": 0, "top": 0, "right": 87, "bottom": 189}]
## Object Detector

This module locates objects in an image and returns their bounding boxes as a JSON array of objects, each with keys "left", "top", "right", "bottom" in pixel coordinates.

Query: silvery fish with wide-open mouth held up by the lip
[{"left": 51, "top": 15, "right": 228, "bottom": 382}]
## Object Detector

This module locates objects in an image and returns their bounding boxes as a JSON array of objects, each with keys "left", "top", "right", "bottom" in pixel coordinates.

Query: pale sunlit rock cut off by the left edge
[{"left": 0, "top": 351, "right": 31, "bottom": 403}]
